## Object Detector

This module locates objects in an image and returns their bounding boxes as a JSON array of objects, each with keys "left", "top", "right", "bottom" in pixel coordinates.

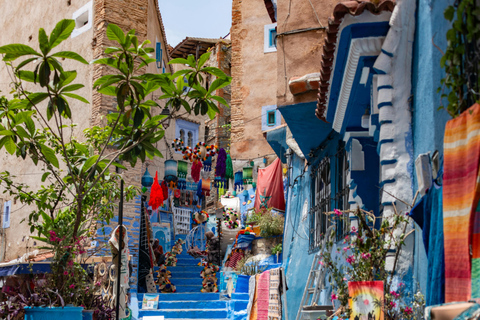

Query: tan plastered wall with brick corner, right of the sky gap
[{"left": 231, "top": 0, "right": 277, "bottom": 160}]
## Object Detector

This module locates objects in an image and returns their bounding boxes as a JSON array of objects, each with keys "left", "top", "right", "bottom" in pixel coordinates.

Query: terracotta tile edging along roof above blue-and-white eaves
[{"left": 315, "top": 0, "right": 395, "bottom": 122}]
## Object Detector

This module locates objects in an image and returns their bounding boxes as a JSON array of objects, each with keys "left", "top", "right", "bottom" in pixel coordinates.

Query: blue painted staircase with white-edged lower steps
[{"left": 138, "top": 236, "right": 248, "bottom": 320}]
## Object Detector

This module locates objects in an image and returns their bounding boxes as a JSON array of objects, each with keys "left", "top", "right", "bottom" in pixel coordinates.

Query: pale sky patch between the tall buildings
[{"left": 158, "top": 0, "right": 232, "bottom": 47}]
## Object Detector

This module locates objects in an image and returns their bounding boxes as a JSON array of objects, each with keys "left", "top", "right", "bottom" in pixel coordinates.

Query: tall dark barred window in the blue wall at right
[{"left": 309, "top": 145, "right": 350, "bottom": 253}]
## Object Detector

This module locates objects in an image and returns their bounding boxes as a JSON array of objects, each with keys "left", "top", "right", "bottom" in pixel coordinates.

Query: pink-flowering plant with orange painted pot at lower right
[{"left": 320, "top": 209, "right": 424, "bottom": 320}]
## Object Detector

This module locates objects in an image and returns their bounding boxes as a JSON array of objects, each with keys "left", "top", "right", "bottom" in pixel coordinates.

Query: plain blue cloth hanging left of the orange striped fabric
[{"left": 410, "top": 182, "right": 445, "bottom": 306}]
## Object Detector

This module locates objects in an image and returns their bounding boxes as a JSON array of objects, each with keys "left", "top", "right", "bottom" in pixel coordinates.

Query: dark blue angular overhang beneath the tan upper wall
[{"left": 278, "top": 102, "right": 332, "bottom": 159}]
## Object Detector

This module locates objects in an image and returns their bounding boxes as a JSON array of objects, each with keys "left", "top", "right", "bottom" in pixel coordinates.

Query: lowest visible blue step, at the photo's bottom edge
[{"left": 138, "top": 309, "right": 228, "bottom": 319}]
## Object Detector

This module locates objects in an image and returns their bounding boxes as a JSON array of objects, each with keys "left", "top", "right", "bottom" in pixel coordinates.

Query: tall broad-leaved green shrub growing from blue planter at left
[{"left": 0, "top": 19, "right": 231, "bottom": 319}]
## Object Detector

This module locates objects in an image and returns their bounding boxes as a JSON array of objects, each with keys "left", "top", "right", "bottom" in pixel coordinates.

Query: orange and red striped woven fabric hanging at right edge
[{"left": 443, "top": 104, "right": 480, "bottom": 302}]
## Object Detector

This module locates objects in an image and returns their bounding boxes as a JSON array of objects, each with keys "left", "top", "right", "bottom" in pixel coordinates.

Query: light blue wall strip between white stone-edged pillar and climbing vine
[{"left": 412, "top": 0, "right": 453, "bottom": 293}]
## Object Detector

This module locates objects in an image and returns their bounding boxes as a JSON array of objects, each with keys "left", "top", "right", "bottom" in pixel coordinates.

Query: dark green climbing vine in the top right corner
[{"left": 438, "top": 0, "right": 480, "bottom": 118}]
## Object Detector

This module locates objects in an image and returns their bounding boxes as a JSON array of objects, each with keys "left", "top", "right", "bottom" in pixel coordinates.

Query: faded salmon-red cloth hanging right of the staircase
[{"left": 255, "top": 158, "right": 285, "bottom": 211}]
